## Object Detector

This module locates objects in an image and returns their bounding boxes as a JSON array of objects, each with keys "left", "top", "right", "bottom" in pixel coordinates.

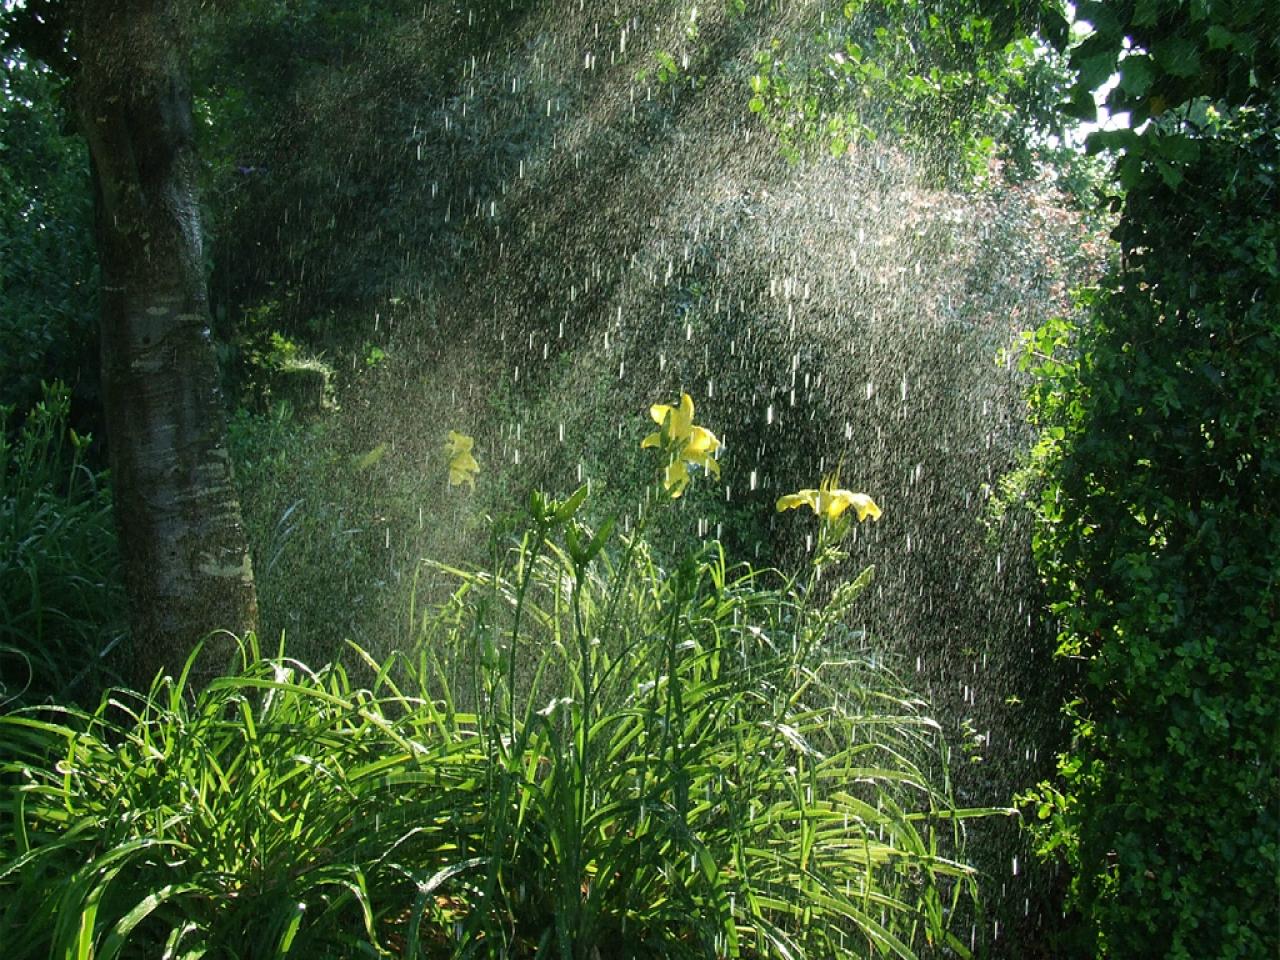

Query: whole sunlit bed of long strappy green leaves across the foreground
[{"left": 0, "top": 495, "right": 998, "bottom": 960}]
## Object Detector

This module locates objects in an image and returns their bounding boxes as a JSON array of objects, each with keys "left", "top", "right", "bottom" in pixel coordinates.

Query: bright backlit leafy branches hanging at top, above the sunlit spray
[{"left": 749, "top": 0, "right": 1075, "bottom": 183}]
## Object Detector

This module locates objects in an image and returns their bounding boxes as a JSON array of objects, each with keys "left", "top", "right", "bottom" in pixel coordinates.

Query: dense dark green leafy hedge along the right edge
[{"left": 1028, "top": 3, "right": 1280, "bottom": 960}]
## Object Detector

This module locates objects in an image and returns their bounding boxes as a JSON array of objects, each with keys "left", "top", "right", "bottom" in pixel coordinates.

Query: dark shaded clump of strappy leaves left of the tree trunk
[{"left": 0, "top": 384, "right": 124, "bottom": 704}]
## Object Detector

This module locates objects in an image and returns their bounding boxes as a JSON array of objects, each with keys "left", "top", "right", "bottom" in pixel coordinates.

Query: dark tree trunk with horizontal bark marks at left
[{"left": 72, "top": 0, "right": 257, "bottom": 689}]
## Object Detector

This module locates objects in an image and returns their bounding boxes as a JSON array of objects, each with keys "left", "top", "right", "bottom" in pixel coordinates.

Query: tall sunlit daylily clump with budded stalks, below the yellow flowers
[{"left": 424, "top": 492, "right": 989, "bottom": 960}]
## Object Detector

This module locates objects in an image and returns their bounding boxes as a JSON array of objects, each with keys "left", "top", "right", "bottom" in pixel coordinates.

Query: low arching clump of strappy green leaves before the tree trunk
[{"left": 0, "top": 640, "right": 483, "bottom": 959}]
